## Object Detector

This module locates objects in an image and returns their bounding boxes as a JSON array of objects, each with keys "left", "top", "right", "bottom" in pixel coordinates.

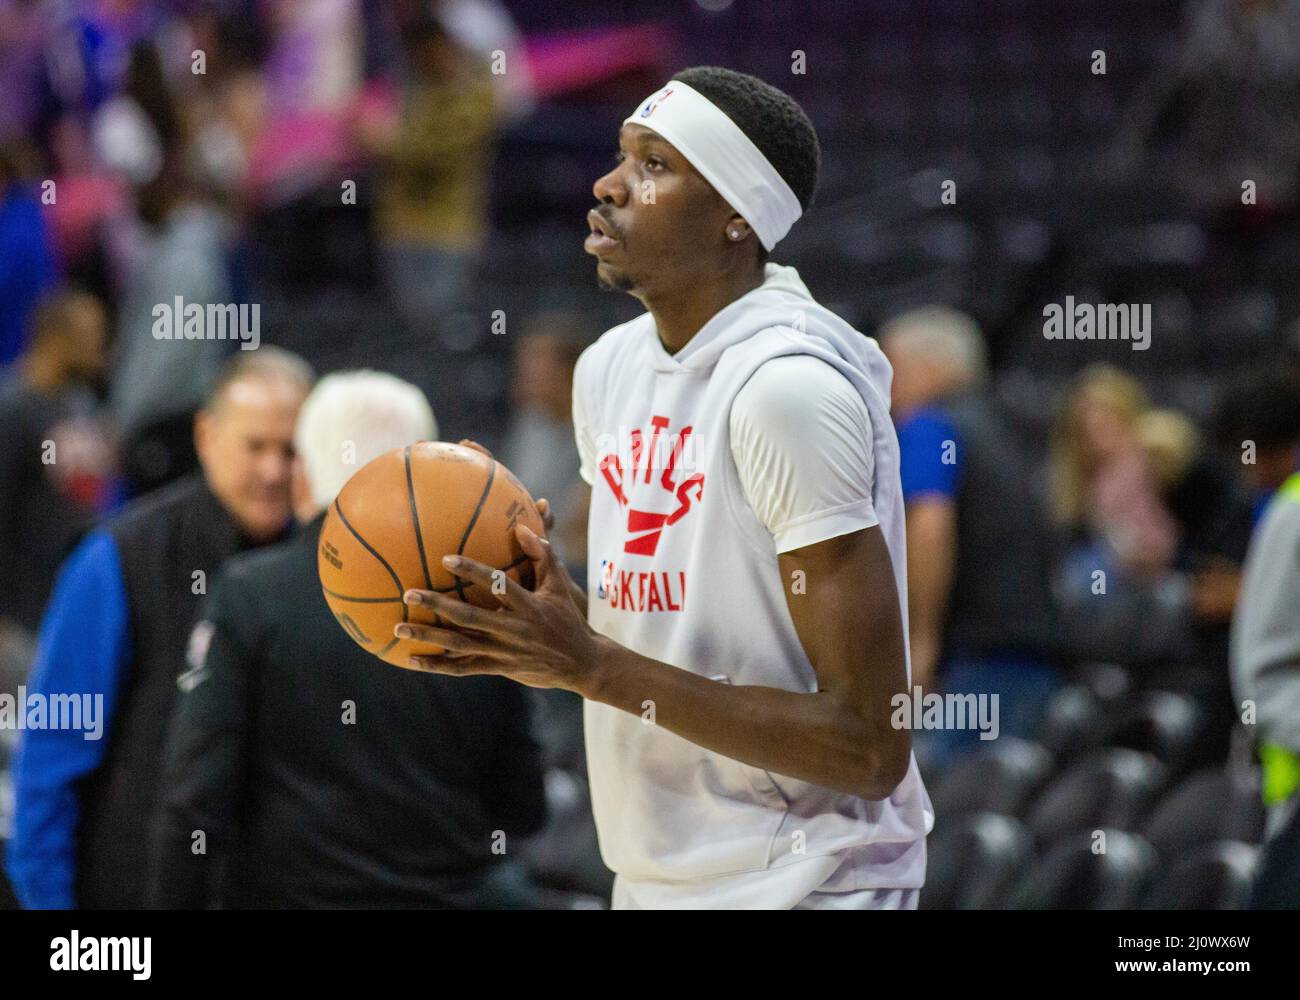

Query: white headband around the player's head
[{"left": 623, "top": 81, "right": 803, "bottom": 250}]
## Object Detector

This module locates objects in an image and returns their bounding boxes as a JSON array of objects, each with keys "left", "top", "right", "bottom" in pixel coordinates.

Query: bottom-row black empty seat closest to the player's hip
[{"left": 920, "top": 813, "right": 1034, "bottom": 910}]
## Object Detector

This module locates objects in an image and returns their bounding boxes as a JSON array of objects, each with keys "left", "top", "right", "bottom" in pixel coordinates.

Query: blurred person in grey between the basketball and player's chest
[{"left": 501, "top": 311, "right": 590, "bottom": 573}]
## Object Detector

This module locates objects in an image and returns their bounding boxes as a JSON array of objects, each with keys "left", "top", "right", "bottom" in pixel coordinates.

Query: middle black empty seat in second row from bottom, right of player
[{"left": 1026, "top": 748, "right": 1166, "bottom": 844}]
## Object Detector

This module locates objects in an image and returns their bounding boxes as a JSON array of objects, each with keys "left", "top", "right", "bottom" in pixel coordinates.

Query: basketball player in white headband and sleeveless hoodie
[{"left": 397, "top": 68, "right": 933, "bottom": 909}]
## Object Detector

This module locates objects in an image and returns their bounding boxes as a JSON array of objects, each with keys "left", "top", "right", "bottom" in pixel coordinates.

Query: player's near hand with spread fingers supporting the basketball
[{"left": 394, "top": 524, "right": 608, "bottom": 697}]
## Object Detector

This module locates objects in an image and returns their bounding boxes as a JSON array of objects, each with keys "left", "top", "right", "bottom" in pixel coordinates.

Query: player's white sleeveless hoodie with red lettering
[{"left": 573, "top": 264, "right": 933, "bottom": 896}]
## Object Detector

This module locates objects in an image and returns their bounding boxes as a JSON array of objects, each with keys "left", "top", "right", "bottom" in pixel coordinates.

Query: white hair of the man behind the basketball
[{"left": 294, "top": 369, "right": 438, "bottom": 508}]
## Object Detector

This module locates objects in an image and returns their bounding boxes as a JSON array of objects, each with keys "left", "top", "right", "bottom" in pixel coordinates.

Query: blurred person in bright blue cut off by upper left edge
[{"left": 0, "top": 146, "right": 59, "bottom": 368}]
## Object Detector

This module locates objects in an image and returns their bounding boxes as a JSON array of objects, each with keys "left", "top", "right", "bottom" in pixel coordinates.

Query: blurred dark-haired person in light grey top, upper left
[{"left": 109, "top": 164, "right": 237, "bottom": 492}]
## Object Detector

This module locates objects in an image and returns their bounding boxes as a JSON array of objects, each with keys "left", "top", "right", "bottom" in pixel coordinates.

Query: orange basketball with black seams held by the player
[{"left": 316, "top": 441, "right": 542, "bottom": 667}]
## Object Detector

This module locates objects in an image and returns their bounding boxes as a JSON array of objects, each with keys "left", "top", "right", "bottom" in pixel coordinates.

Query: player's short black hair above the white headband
[{"left": 673, "top": 66, "right": 822, "bottom": 212}]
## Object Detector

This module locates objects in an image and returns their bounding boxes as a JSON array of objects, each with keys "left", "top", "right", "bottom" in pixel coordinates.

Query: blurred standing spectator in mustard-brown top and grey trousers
[{"left": 358, "top": 17, "right": 497, "bottom": 330}]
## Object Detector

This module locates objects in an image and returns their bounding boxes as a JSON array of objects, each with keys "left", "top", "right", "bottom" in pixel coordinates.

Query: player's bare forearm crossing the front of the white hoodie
[{"left": 582, "top": 638, "right": 907, "bottom": 800}]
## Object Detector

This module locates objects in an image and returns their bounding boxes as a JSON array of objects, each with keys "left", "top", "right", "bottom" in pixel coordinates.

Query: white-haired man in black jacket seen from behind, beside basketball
[{"left": 150, "top": 371, "right": 545, "bottom": 909}]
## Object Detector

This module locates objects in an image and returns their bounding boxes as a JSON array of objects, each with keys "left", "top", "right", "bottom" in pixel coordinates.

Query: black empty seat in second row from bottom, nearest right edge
[{"left": 1143, "top": 767, "right": 1264, "bottom": 865}]
